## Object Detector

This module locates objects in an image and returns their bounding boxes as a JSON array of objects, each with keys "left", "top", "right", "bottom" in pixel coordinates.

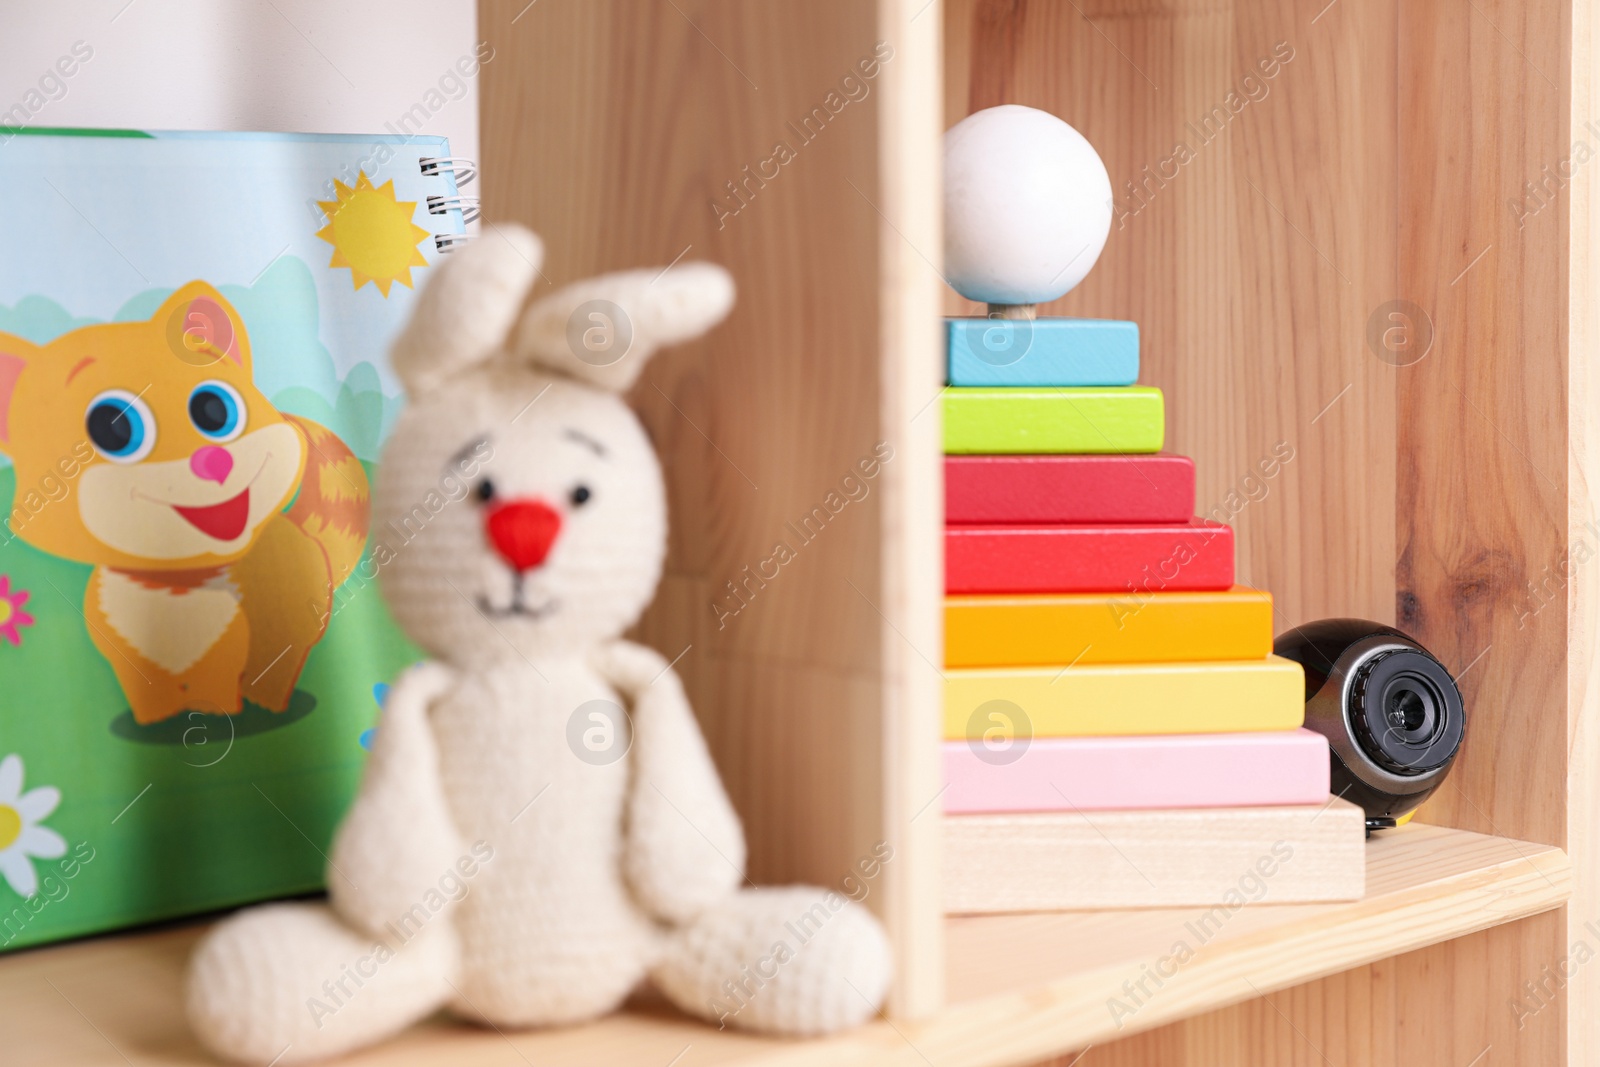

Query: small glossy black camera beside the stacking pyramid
[{"left": 1272, "top": 619, "right": 1466, "bottom": 830}]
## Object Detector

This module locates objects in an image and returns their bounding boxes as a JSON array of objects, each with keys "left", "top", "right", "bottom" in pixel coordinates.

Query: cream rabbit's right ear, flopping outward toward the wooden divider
[{"left": 512, "top": 262, "right": 733, "bottom": 392}]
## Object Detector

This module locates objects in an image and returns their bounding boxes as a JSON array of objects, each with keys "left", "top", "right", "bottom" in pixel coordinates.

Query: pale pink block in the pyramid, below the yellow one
[{"left": 944, "top": 729, "right": 1328, "bottom": 814}]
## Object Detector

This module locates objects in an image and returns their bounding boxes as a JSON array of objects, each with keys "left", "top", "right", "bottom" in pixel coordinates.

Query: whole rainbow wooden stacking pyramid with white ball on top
[{"left": 942, "top": 106, "right": 1365, "bottom": 912}]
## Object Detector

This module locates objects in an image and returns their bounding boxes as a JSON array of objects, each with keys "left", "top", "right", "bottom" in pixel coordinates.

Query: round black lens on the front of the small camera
[{"left": 1349, "top": 649, "right": 1462, "bottom": 774}]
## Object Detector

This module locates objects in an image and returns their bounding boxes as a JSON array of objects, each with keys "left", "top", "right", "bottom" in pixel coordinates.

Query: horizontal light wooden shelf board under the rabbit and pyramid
[{"left": 0, "top": 825, "right": 1571, "bottom": 1067}]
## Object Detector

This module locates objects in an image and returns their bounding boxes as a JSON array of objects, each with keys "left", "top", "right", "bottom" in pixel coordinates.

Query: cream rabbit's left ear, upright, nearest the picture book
[{"left": 390, "top": 224, "right": 544, "bottom": 395}]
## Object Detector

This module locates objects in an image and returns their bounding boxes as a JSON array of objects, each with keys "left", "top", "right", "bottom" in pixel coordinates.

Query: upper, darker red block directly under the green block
[{"left": 944, "top": 454, "right": 1195, "bottom": 523}]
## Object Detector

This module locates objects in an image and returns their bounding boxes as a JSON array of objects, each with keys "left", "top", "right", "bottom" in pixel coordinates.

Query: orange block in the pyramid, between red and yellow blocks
[{"left": 944, "top": 585, "right": 1272, "bottom": 670}]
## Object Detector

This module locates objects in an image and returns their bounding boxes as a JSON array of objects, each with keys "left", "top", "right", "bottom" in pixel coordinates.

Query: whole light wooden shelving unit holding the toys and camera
[{"left": 12, "top": 0, "right": 1600, "bottom": 1067}]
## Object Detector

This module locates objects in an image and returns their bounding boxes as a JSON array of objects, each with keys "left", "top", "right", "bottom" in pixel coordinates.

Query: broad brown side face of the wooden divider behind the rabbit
[{"left": 480, "top": 0, "right": 882, "bottom": 881}]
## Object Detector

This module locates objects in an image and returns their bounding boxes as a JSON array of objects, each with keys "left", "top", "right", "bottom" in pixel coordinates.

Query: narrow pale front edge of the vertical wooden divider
[{"left": 878, "top": 0, "right": 944, "bottom": 1017}]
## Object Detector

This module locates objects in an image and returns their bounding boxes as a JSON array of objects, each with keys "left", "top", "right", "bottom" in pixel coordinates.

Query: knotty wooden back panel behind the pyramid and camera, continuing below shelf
[{"left": 946, "top": 0, "right": 1568, "bottom": 1067}]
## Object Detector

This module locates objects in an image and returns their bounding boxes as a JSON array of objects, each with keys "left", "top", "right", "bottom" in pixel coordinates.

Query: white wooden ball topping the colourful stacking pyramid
[{"left": 944, "top": 104, "right": 1112, "bottom": 304}]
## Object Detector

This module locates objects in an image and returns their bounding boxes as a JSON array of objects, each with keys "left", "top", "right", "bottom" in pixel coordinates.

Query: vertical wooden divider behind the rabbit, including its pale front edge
[{"left": 480, "top": 0, "right": 941, "bottom": 1006}]
